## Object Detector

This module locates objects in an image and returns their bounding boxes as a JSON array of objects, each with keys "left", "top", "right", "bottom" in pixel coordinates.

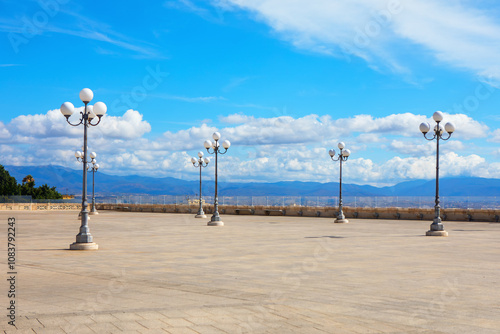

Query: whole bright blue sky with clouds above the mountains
[{"left": 0, "top": 0, "right": 500, "bottom": 186}]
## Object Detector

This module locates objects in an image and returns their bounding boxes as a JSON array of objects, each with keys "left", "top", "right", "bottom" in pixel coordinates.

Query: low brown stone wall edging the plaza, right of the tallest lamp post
[{"left": 97, "top": 204, "right": 500, "bottom": 222}]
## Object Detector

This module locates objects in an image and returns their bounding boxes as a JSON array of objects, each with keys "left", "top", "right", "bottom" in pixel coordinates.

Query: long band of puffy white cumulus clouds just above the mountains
[{"left": 0, "top": 110, "right": 500, "bottom": 185}]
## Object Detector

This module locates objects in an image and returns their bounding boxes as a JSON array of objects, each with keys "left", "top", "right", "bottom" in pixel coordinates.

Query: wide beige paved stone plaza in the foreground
[{"left": 0, "top": 211, "right": 500, "bottom": 334}]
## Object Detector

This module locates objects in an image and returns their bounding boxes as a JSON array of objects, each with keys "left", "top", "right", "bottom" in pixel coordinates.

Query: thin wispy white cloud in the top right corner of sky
[{"left": 216, "top": 0, "right": 500, "bottom": 79}]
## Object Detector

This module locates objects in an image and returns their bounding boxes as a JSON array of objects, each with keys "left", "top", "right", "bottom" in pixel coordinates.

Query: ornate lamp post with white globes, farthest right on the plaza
[{"left": 420, "top": 111, "right": 455, "bottom": 237}]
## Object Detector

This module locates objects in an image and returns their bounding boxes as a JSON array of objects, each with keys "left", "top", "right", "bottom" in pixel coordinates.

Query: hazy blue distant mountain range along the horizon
[{"left": 4, "top": 166, "right": 500, "bottom": 196}]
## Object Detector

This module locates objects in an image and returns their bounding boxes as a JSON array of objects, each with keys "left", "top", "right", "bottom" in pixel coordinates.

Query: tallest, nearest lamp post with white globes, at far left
[{"left": 61, "top": 88, "right": 107, "bottom": 250}]
